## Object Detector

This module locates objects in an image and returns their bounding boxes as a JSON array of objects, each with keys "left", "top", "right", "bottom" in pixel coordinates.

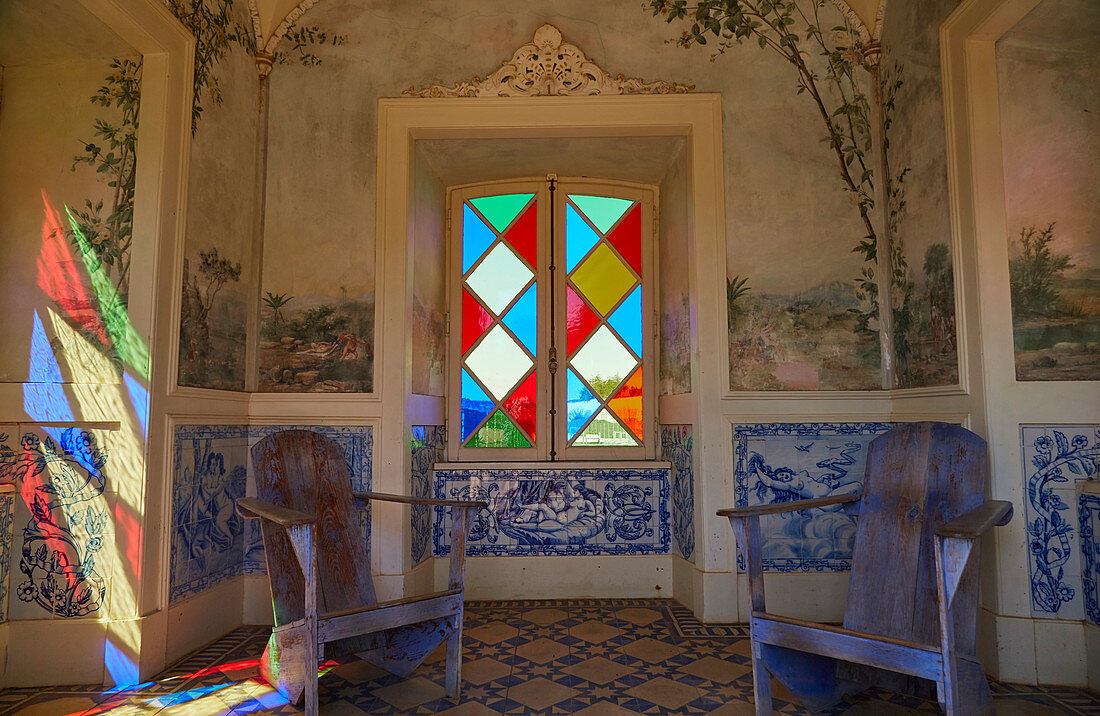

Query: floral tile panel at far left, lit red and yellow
[{"left": 0, "top": 428, "right": 110, "bottom": 618}]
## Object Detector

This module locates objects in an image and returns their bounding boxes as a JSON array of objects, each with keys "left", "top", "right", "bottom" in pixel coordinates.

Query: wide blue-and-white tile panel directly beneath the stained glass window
[{"left": 432, "top": 467, "right": 672, "bottom": 557}]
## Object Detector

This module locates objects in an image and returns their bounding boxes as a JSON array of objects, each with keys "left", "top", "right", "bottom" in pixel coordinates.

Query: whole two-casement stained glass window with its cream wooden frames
[{"left": 450, "top": 180, "right": 653, "bottom": 460}]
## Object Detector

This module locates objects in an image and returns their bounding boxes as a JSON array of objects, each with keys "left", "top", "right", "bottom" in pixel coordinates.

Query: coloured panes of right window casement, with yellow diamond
[{"left": 565, "top": 195, "right": 645, "bottom": 447}]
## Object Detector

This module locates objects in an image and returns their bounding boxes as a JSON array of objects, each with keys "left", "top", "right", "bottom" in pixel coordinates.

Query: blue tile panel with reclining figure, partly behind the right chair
[{"left": 733, "top": 422, "right": 891, "bottom": 572}]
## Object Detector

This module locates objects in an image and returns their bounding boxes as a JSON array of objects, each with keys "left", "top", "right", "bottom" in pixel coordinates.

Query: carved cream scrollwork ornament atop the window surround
[{"left": 402, "top": 23, "right": 695, "bottom": 97}]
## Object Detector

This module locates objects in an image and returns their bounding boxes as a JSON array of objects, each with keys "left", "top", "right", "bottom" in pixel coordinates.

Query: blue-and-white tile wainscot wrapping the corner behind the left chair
[{"left": 169, "top": 425, "right": 374, "bottom": 603}]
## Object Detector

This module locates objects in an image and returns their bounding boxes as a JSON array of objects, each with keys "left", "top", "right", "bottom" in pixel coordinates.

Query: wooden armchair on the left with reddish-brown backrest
[{"left": 237, "top": 430, "right": 486, "bottom": 716}]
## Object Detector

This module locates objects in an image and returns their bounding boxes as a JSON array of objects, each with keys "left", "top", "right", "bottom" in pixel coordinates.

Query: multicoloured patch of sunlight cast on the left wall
[{"left": 0, "top": 191, "right": 150, "bottom": 685}]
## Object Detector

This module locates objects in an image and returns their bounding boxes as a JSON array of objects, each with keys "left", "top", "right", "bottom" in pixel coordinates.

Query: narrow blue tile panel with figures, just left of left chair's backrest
[{"left": 168, "top": 426, "right": 249, "bottom": 604}]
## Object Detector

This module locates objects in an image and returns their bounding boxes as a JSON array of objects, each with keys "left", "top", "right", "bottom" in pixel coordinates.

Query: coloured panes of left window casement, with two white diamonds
[{"left": 460, "top": 194, "right": 538, "bottom": 448}]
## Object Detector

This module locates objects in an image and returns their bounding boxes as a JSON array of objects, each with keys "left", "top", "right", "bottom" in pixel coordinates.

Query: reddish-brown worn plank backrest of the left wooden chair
[{"left": 252, "top": 430, "right": 377, "bottom": 625}]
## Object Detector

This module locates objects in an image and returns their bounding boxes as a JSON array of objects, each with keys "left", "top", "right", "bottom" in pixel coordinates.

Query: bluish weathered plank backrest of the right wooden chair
[{"left": 844, "top": 422, "right": 989, "bottom": 654}]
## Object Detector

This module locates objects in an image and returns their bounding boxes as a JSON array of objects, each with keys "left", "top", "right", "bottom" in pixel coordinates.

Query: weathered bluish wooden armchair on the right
[{"left": 718, "top": 422, "right": 1012, "bottom": 714}]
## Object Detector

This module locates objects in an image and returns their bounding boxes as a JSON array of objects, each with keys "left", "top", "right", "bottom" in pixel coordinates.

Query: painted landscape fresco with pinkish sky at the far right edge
[{"left": 997, "top": 0, "right": 1100, "bottom": 381}]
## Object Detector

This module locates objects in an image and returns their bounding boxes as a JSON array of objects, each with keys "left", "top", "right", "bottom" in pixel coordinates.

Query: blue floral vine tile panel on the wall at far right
[{"left": 1020, "top": 426, "right": 1100, "bottom": 619}]
